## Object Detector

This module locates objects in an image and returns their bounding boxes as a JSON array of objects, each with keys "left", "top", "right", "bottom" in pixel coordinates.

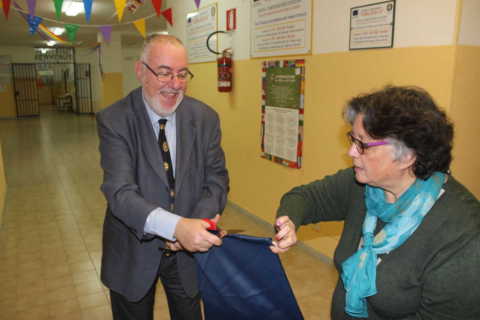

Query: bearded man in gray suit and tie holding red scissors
[{"left": 97, "top": 35, "right": 229, "bottom": 320}]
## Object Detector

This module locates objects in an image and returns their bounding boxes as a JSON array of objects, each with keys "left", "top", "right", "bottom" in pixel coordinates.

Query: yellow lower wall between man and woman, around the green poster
[{"left": 188, "top": 46, "right": 464, "bottom": 256}]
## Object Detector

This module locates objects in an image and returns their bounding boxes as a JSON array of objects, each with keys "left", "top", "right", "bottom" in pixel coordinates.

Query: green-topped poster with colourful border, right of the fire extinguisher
[{"left": 261, "top": 60, "right": 305, "bottom": 168}]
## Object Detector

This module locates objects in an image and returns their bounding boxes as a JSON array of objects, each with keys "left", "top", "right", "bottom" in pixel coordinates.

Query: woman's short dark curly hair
[{"left": 344, "top": 86, "right": 453, "bottom": 179}]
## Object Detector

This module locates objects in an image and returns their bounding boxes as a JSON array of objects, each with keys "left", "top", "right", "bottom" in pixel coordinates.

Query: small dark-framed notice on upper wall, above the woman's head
[{"left": 350, "top": 0, "right": 395, "bottom": 50}]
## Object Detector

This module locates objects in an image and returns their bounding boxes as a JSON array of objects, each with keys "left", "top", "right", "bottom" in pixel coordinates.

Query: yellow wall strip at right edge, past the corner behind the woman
[{"left": 450, "top": 46, "right": 480, "bottom": 198}]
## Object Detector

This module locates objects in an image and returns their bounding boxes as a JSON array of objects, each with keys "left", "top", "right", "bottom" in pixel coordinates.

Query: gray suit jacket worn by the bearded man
[{"left": 97, "top": 88, "right": 229, "bottom": 301}]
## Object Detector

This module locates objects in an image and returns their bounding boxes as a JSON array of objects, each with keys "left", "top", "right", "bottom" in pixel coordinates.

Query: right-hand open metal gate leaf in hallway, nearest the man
[{"left": 74, "top": 63, "right": 93, "bottom": 114}]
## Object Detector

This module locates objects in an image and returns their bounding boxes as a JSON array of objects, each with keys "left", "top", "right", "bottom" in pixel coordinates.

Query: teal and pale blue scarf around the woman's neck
[{"left": 342, "top": 172, "right": 446, "bottom": 318}]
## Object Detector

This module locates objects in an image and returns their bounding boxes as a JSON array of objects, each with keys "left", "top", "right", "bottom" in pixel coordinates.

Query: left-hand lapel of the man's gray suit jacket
[{"left": 131, "top": 88, "right": 168, "bottom": 186}]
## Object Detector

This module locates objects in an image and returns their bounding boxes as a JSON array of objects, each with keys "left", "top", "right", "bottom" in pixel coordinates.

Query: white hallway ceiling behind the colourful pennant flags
[{"left": 0, "top": 0, "right": 167, "bottom": 47}]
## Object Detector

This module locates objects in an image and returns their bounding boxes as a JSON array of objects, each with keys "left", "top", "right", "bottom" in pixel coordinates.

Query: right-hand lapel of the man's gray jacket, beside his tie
[{"left": 175, "top": 97, "right": 195, "bottom": 192}]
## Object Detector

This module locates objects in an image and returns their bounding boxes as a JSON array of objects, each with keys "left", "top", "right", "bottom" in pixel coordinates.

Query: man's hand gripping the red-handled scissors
[{"left": 175, "top": 214, "right": 222, "bottom": 252}]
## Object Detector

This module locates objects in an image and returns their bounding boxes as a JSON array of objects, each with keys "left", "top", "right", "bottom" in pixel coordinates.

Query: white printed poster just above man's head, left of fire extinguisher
[{"left": 186, "top": 3, "right": 218, "bottom": 63}]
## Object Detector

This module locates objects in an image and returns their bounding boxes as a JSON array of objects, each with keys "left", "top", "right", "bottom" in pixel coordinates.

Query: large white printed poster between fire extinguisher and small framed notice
[{"left": 250, "top": 0, "right": 311, "bottom": 57}]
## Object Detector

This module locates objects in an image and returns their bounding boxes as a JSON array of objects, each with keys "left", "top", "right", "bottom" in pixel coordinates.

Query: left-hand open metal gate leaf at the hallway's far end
[{"left": 12, "top": 63, "right": 40, "bottom": 118}]
